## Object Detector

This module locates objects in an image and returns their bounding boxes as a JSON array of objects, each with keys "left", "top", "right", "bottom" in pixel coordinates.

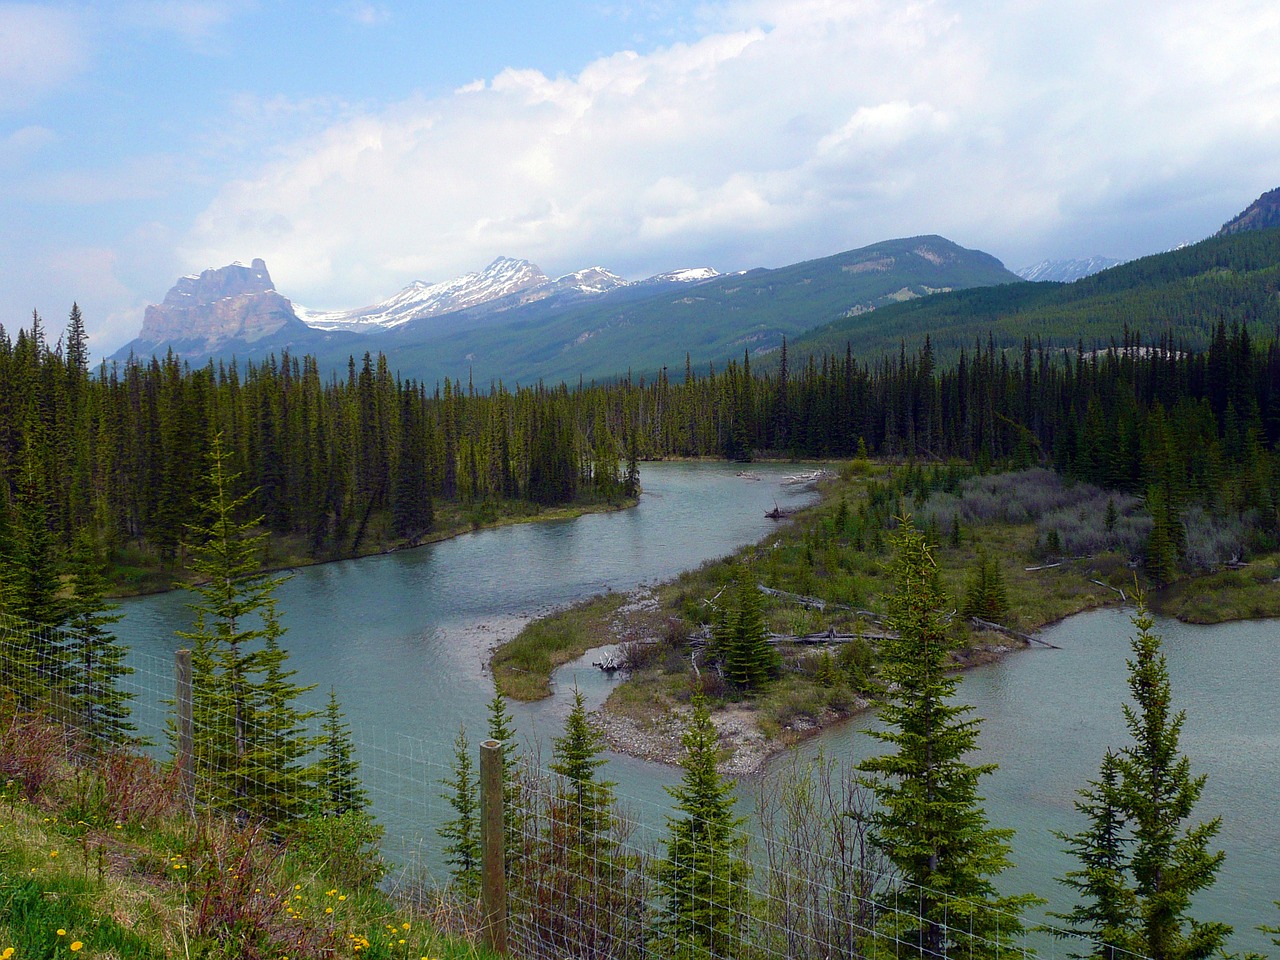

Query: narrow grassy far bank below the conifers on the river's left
[{"left": 109, "top": 497, "right": 639, "bottom": 600}]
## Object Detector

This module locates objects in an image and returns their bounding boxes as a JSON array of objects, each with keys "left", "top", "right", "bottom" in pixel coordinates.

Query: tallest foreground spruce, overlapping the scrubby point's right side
[{"left": 859, "top": 518, "right": 1034, "bottom": 957}]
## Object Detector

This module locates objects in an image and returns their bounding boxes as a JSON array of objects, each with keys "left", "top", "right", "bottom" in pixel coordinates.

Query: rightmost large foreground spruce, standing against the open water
[{"left": 1066, "top": 598, "right": 1231, "bottom": 960}]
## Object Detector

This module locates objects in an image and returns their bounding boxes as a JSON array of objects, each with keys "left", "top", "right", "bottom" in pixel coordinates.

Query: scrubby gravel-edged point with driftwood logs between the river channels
[{"left": 492, "top": 461, "right": 1280, "bottom": 777}]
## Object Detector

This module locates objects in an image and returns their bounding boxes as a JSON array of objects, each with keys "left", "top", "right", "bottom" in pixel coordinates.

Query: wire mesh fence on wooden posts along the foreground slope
[{"left": 0, "top": 613, "right": 1152, "bottom": 960}]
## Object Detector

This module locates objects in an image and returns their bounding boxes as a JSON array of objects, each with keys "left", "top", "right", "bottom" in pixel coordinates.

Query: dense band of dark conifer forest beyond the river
[{"left": 0, "top": 308, "right": 1280, "bottom": 576}]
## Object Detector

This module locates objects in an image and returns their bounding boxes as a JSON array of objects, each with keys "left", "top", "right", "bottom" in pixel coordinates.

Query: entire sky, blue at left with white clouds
[{"left": 0, "top": 0, "right": 1280, "bottom": 356}]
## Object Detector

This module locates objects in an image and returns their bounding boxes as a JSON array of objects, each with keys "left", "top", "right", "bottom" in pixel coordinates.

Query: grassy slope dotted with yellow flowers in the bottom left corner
[{"left": 0, "top": 707, "right": 499, "bottom": 960}]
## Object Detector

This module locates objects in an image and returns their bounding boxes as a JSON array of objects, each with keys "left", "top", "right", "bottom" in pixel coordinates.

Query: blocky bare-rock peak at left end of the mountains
[{"left": 138, "top": 260, "right": 301, "bottom": 352}]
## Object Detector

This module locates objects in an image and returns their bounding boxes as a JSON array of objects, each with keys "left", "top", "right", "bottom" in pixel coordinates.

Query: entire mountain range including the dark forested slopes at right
[{"left": 116, "top": 189, "right": 1280, "bottom": 384}]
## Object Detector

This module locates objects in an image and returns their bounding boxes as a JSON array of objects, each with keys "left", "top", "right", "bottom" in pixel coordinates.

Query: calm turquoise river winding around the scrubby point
[{"left": 118, "top": 463, "right": 1280, "bottom": 952}]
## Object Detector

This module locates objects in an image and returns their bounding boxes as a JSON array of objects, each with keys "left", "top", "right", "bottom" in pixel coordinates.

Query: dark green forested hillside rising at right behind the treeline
[{"left": 791, "top": 229, "right": 1280, "bottom": 361}]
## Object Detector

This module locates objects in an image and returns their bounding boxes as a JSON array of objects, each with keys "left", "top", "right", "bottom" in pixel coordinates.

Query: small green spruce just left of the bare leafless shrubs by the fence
[{"left": 657, "top": 698, "right": 749, "bottom": 960}]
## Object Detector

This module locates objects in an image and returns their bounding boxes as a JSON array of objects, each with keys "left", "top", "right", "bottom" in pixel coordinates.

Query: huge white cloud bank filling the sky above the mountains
[{"left": 180, "top": 0, "right": 1280, "bottom": 307}]
